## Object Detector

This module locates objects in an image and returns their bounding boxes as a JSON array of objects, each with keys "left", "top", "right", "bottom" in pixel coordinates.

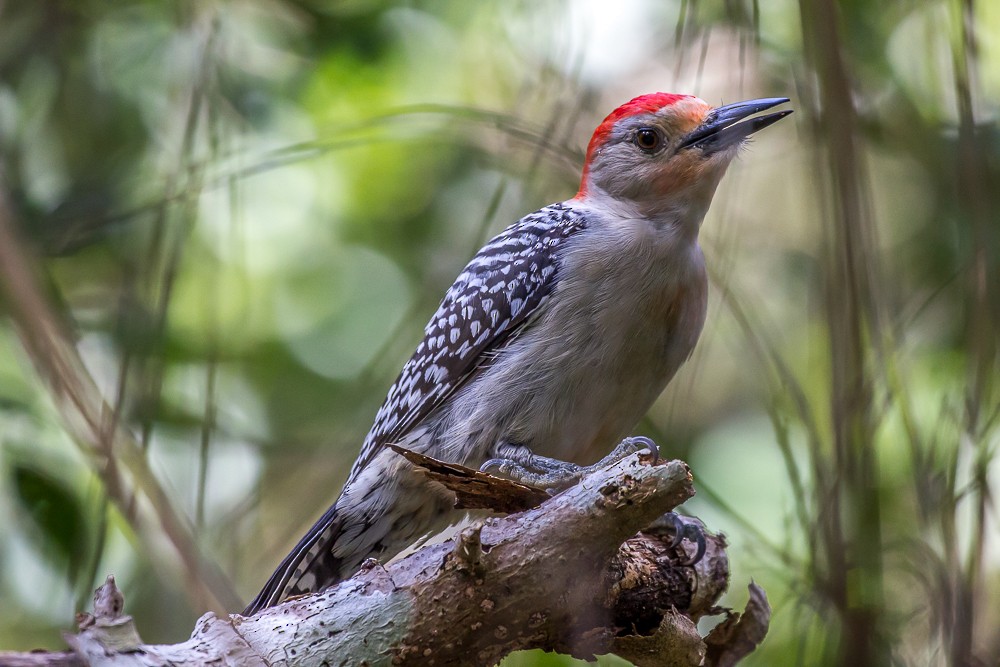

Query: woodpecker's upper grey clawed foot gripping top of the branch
[{"left": 479, "top": 436, "right": 660, "bottom": 491}]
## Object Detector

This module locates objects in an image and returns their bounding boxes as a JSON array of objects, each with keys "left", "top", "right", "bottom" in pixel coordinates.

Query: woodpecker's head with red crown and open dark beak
[{"left": 577, "top": 93, "right": 792, "bottom": 222}]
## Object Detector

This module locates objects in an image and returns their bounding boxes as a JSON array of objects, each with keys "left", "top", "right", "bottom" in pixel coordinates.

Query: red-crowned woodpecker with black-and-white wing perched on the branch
[{"left": 245, "top": 93, "right": 791, "bottom": 614}]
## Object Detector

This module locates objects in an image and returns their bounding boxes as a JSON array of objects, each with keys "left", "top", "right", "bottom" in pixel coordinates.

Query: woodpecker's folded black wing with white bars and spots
[{"left": 348, "top": 204, "right": 585, "bottom": 481}]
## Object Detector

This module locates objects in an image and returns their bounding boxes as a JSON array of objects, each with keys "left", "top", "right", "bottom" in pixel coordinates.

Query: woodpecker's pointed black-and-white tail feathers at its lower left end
[{"left": 243, "top": 505, "right": 341, "bottom": 616}]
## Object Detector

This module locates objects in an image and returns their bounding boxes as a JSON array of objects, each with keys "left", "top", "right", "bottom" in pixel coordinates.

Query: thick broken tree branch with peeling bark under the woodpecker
[{"left": 0, "top": 455, "right": 768, "bottom": 667}]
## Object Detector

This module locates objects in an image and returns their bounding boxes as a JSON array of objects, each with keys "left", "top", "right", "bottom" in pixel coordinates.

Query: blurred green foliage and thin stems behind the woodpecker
[{"left": 0, "top": 0, "right": 1000, "bottom": 666}]
